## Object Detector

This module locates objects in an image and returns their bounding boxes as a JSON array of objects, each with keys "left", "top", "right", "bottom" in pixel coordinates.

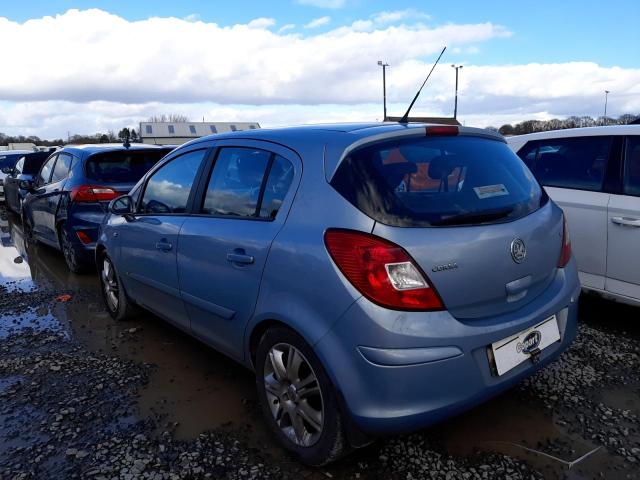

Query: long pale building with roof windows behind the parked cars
[{"left": 140, "top": 122, "right": 260, "bottom": 145}]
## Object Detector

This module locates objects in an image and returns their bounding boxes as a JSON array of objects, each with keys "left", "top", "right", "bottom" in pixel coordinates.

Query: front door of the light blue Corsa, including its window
[{"left": 117, "top": 150, "right": 207, "bottom": 329}]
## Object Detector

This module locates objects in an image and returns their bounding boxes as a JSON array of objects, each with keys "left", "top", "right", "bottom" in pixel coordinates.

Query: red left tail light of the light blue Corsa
[{"left": 324, "top": 230, "right": 444, "bottom": 311}]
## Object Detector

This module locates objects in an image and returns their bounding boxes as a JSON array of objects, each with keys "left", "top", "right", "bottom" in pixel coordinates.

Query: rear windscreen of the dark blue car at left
[{"left": 86, "top": 149, "right": 170, "bottom": 183}]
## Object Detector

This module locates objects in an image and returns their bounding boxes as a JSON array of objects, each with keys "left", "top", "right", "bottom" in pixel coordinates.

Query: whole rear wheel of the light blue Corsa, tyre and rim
[{"left": 256, "top": 327, "right": 347, "bottom": 466}]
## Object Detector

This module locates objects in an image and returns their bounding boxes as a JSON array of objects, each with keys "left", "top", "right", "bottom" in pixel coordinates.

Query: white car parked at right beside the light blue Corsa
[{"left": 507, "top": 125, "right": 640, "bottom": 306}]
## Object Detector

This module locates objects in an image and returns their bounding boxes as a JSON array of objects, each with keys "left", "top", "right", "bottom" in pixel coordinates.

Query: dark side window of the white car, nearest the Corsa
[{"left": 532, "top": 137, "right": 612, "bottom": 191}]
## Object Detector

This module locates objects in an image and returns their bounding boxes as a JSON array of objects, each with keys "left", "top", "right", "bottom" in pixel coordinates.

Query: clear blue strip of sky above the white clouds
[{"left": 0, "top": 0, "right": 640, "bottom": 67}]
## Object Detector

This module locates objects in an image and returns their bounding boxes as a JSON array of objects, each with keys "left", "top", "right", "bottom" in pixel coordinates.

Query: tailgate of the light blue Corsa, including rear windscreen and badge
[{"left": 331, "top": 131, "right": 563, "bottom": 319}]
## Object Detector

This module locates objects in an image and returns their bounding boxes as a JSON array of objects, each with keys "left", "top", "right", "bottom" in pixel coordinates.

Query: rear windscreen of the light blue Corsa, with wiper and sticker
[{"left": 331, "top": 136, "right": 548, "bottom": 227}]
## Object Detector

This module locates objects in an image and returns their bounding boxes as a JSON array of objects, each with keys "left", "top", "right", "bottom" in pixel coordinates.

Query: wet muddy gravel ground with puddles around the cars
[{"left": 0, "top": 207, "right": 640, "bottom": 480}]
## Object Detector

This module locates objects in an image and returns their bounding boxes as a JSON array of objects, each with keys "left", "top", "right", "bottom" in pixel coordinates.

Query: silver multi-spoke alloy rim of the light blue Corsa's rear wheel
[{"left": 264, "top": 343, "right": 324, "bottom": 447}]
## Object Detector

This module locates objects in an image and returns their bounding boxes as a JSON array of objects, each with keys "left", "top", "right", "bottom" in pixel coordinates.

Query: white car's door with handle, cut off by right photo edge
[{"left": 606, "top": 136, "right": 640, "bottom": 299}]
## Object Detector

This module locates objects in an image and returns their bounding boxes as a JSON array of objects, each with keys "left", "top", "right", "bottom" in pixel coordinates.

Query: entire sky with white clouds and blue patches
[{"left": 0, "top": 0, "right": 640, "bottom": 138}]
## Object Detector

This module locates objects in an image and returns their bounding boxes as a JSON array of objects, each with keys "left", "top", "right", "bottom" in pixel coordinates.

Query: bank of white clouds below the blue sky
[{"left": 0, "top": 9, "right": 640, "bottom": 138}]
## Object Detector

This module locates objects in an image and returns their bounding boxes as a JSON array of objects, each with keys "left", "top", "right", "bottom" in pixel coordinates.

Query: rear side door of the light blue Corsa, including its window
[{"left": 178, "top": 140, "right": 302, "bottom": 359}]
